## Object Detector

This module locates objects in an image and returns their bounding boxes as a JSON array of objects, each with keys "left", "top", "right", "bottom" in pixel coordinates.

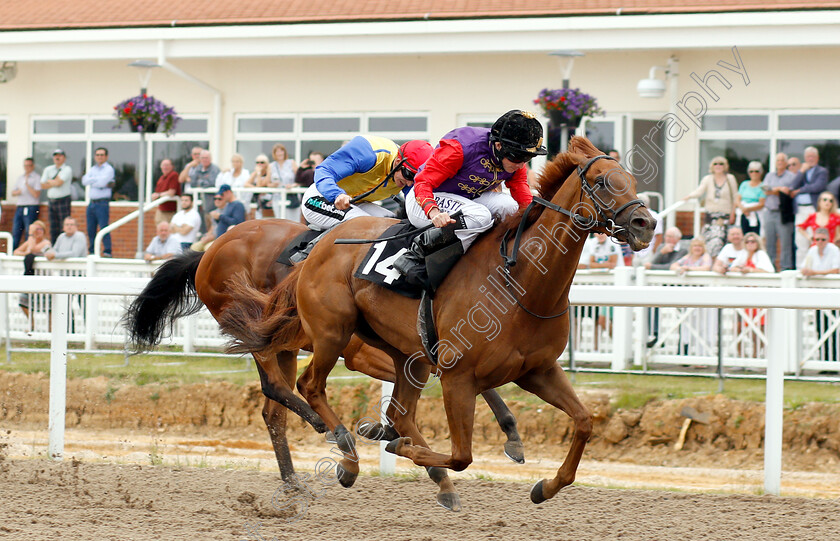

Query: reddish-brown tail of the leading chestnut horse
[{"left": 219, "top": 265, "right": 309, "bottom": 353}]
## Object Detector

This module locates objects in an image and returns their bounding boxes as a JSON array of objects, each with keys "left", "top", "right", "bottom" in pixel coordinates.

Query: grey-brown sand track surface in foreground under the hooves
[{"left": 0, "top": 452, "right": 840, "bottom": 541}]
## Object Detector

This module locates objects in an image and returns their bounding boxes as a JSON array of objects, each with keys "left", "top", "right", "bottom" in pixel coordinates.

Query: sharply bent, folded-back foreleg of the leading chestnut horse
[{"left": 386, "top": 372, "right": 476, "bottom": 471}]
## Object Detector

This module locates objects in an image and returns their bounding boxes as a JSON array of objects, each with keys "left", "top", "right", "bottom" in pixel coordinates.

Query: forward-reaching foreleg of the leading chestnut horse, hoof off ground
[{"left": 516, "top": 364, "right": 592, "bottom": 503}]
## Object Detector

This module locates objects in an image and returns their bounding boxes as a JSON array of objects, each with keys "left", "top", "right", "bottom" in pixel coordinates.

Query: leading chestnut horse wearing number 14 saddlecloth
[{"left": 220, "top": 137, "right": 656, "bottom": 503}]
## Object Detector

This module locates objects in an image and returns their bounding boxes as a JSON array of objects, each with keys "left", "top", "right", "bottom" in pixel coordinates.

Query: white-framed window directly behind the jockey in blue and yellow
[{"left": 235, "top": 113, "right": 429, "bottom": 166}]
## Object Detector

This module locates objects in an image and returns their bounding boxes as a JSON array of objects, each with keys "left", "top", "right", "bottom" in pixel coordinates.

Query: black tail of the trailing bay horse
[{"left": 123, "top": 250, "right": 204, "bottom": 352}]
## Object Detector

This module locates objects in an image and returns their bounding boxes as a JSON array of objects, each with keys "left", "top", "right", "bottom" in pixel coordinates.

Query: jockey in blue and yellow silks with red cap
[{"left": 302, "top": 135, "right": 432, "bottom": 230}]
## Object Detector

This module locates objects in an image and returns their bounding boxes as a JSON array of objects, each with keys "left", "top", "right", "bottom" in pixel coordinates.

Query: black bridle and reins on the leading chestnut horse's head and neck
[{"left": 499, "top": 154, "right": 647, "bottom": 319}]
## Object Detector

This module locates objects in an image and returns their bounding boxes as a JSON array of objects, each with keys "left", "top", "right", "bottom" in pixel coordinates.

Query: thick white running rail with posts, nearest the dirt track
[{"left": 0, "top": 276, "right": 840, "bottom": 495}]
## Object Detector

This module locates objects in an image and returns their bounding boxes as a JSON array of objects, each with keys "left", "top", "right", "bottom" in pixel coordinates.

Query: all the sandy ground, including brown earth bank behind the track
[{"left": 0, "top": 373, "right": 840, "bottom": 541}]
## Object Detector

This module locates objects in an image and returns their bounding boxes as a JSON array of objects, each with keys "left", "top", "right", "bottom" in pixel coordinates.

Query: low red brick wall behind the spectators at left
[{"left": 0, "top": 203, "right": 272, "bottom": 259}]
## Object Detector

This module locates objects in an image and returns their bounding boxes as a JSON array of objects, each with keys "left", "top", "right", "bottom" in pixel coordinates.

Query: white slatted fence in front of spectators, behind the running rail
[{"left": 0, "top": 255, "right": 840, "bottom": 374}]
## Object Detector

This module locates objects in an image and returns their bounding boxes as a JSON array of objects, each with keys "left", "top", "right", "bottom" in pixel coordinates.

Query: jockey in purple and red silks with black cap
[{"left": 394, "top": 109, "right": 546, "bottom": 286}]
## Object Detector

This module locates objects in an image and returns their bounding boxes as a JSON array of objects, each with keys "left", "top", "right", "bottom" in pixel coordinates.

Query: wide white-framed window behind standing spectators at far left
[{"left": 32, "top": 116, "right": 209, "bottom": 201}]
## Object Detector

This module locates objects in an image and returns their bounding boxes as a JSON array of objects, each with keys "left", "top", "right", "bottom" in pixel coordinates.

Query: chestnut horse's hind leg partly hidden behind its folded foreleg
[{"left": 380, "top": 353, "right": 461, "bottom": 511}]
